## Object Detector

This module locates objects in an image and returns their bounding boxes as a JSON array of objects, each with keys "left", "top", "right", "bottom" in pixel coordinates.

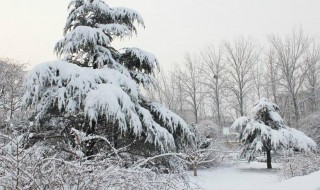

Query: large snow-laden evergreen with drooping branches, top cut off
[{"left": 24, "top": 0, "right": 194, "bottom": 155}]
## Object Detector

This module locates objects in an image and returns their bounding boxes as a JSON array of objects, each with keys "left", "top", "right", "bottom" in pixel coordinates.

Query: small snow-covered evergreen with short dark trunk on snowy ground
[{"left": 232, "top": 98, "right": 317, "bottom": 168}]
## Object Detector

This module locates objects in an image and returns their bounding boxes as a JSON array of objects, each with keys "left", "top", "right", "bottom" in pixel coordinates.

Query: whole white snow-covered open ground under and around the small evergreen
[{"left": 190, "top": 162, "right": 320, "bottom": 190}]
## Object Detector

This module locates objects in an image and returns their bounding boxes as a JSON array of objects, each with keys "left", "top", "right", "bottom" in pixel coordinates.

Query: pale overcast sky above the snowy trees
[{"left": 0, "top": 0, "right": 320, "bottom": 68}]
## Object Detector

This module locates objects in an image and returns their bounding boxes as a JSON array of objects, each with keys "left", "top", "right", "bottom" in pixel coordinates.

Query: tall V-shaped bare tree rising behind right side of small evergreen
[{"left": 269, "top": 29, "right": 311, "bottom": 121}]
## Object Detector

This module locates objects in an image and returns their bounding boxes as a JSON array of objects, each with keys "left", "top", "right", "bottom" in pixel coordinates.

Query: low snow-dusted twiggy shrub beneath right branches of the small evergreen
[{"left": 280, "top": 154, "right": 320, "bottom": 179}]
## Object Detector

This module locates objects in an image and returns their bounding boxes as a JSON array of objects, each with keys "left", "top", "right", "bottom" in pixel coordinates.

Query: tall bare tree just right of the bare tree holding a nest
[{"left": 224, "top": 37, "right": 260, "bottom": 116}]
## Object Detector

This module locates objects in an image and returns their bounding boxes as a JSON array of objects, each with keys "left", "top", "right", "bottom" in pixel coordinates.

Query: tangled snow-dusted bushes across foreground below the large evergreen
[{"left": 0, "top": 134, "right": 190, "bottom": 190}]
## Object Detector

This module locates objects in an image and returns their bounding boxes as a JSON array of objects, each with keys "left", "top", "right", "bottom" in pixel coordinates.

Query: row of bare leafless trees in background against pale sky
[{"left": 147, "top": 29, "right": 320, "bottom": 126}]
